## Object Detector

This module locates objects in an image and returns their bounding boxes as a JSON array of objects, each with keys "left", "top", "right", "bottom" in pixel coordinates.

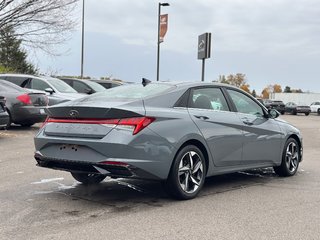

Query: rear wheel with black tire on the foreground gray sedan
[{"left": 164, "top": 145, "right": 207, "bottom": 200}]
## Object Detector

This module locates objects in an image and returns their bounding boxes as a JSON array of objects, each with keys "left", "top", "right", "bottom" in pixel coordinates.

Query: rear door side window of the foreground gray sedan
[{"left": 188, "top": 88, "right": 230, "bottom": 111}]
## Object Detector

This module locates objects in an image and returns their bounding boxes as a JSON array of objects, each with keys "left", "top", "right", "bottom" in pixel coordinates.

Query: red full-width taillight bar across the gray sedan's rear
[{"left": 42, "top": 117, "right": 155, "bottom": 135}]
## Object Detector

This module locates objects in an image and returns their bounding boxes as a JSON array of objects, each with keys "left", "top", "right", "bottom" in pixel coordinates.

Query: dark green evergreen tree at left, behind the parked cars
[{"left": 0, "top": 26, "right": 37, "bottom": 74}]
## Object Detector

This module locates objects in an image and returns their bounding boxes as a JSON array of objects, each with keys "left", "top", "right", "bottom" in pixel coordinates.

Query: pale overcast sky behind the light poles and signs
[{"left": 34, "top": 0, "right": 320, "bottom": 93}]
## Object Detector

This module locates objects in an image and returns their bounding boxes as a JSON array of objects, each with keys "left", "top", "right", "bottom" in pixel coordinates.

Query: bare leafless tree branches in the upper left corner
[{"left": 0, "top": 0, "right": 79, "bottom": 54}]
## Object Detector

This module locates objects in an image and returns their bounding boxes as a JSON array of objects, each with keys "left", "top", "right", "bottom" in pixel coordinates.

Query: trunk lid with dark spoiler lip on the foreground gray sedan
[{"left": 45, "top": 100, "right": 145, "bottom": 138}]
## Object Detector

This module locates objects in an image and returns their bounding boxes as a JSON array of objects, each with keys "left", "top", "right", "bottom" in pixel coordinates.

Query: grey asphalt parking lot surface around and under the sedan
[{"left": 0, "top": 115, "right": 320, "bottom": 239}]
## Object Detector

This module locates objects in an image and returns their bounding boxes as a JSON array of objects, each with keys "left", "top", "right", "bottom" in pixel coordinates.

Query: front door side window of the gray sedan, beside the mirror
[{"left": 227, "top": 89, "right": 264, "bottom": 116}]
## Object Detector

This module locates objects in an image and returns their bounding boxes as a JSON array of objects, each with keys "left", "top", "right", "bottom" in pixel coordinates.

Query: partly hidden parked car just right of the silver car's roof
[{"left": 59, "top": 78, "right": 106, "bottom": 94}]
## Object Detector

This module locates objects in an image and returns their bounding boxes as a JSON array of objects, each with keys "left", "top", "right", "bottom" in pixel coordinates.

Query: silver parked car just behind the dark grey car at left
[{"left": 0, "top": 74, "right": 84, "bottom": 105}]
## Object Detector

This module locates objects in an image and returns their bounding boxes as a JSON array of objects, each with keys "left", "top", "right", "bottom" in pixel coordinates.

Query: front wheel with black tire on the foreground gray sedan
[{"left": 273, "top": 138, "right": 301, "bottom": 177}]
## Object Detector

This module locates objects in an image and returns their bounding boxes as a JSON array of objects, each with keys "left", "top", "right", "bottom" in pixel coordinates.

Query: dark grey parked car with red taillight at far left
[{"left": 0, "top": 80, "right": 48, "bottom": 128}]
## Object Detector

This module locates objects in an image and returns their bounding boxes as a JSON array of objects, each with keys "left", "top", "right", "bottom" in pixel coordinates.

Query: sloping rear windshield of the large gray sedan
[{"left": 88, "top": 83, "right": 175, "bottom": 101}]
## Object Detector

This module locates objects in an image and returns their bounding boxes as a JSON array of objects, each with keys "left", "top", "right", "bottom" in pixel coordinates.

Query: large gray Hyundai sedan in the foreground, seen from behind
[{"left": 35, "top": 82, "right": 302, "bottom": 199}]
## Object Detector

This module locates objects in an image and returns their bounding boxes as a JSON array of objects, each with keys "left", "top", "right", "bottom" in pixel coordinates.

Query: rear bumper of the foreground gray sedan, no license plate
[{"left": 34, "top": 127, "right": 176, "bottom": 179}]
